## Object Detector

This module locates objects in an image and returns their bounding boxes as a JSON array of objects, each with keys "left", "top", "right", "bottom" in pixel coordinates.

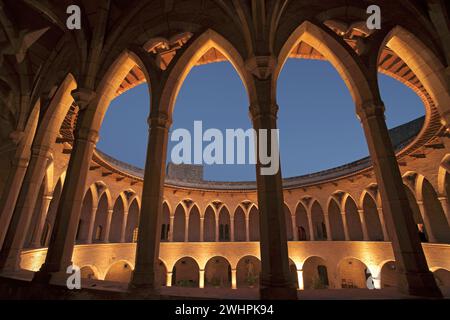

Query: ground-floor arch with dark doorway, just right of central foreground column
[{"left": 303, "top": 256, "right": 331, "bottom": 290}]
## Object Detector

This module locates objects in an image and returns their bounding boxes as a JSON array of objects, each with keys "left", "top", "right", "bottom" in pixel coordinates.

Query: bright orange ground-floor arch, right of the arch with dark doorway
[{"left": 338, "top": 258, "right": 371, "bottom": 288}]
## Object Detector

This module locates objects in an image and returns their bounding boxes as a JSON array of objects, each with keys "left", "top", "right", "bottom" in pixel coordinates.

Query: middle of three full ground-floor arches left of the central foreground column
[{"left": 205, "top": 257, "right": 231, "bottom": 288}]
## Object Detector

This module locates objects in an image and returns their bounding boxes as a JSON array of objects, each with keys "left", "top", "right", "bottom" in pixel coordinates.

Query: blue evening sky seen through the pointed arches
[{"left": 97, "top": 59, "right": 425, "bottom": 181}]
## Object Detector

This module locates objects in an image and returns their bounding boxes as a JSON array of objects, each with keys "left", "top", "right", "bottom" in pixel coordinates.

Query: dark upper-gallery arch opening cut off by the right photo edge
[{"left": 422, "top": 179, "right": 450, "bottom": 243}]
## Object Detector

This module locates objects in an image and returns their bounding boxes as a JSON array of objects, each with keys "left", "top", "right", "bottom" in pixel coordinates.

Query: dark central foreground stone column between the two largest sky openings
[{"left": 250, "top": 95, "right": 297, "bottom": 299}]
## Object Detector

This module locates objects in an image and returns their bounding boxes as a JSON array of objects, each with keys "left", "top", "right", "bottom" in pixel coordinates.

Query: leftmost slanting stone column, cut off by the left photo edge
[{"left": 0, "top": 158, "right": 29, "bottom": 248}]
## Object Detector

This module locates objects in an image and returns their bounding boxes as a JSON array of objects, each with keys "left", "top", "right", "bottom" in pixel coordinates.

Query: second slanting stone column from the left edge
[{"left": 0, "top": 146, "right": 51, "bottom": 271}]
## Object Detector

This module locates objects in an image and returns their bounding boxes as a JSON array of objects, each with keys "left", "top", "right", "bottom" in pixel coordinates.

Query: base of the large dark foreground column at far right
[{"left": 398, "top": 272, "right": 443, "bottom": 299}]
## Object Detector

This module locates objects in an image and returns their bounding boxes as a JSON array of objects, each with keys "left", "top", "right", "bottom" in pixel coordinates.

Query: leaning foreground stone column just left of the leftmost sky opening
[{"left": 34, "top": 89, "right": 98, "bottom": 282}]
